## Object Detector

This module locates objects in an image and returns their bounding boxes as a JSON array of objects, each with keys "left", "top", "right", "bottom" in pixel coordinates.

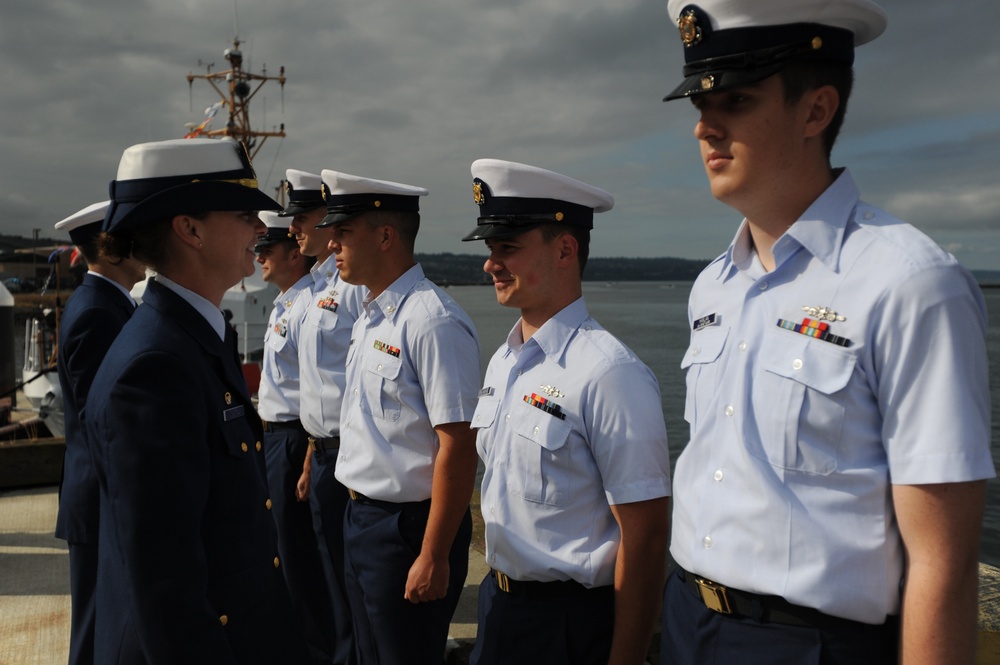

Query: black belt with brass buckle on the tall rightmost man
[{"left": 677, "top": 568, "right": 867, "bottom": 629}]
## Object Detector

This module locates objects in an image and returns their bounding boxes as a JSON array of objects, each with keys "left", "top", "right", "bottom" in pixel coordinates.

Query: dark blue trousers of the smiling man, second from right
[{"left": 469, "top": 573, "right": 616, "bottom": 665}]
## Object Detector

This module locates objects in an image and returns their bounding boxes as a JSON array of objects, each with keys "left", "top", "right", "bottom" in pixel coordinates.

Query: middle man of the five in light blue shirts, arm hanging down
[{"left": 321, "top": 170, "right": 479, "bottom": 665}]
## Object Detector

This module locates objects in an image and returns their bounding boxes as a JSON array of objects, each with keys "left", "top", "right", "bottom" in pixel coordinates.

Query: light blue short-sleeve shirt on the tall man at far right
[{"left": 670, "top": 171, "right": 995, "bottom": 624}]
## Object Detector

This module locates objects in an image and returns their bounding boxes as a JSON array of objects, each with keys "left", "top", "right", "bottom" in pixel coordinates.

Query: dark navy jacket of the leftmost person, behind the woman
[{"left": 56, "top": 274, "right": 135, "bottom": 544}]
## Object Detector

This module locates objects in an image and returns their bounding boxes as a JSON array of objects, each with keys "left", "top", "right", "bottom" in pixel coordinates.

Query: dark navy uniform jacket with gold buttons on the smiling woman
[{"left": 84, "top": 279, "right": 304, "bottom": 665}]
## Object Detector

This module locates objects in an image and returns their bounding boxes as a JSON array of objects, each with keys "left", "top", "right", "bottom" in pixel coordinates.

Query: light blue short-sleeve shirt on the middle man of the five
[{"left": 336, "top": 264, "right": 480, "bottom": 503}]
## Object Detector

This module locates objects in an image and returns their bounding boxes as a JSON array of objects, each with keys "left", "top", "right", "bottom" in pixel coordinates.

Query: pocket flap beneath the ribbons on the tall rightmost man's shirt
[{"left": 761, "top": 330, "right": 857, "bottom": 395}]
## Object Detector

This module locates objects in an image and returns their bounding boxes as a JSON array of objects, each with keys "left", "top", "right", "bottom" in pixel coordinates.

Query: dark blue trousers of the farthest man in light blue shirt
[{"left": 264, "top": 421, "right": 340, "bottom": 664}]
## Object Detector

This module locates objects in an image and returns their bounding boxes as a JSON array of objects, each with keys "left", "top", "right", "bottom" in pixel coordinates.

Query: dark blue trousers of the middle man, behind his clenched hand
[{"left": 344, "top": 499, "right": 472, "bottom": 665}]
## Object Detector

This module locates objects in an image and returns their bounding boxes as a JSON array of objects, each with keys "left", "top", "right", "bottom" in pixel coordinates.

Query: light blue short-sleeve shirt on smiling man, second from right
[{"left": 472, "top": 298, "right": 670, "bottom": 587}]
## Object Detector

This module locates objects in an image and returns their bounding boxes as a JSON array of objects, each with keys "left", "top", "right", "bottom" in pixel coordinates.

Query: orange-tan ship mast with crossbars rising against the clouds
[{"left": 186, "top": 37, "right": 285, "bottom": 160}]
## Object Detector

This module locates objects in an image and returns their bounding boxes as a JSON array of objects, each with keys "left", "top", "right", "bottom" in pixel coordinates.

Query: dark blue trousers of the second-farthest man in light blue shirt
[{"left": 309, "top": 448, "right": 358, "bottom": 665}]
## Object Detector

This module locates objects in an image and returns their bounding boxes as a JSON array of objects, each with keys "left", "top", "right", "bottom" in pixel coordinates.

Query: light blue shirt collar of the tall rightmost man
[{"left": 716, "top": 169, "right": 860, "bottom": 281}]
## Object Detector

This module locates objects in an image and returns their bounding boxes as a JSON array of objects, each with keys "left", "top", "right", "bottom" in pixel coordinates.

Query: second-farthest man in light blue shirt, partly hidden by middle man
[{"left": 279, "top": 169, "right": 363, "bottom": 665}]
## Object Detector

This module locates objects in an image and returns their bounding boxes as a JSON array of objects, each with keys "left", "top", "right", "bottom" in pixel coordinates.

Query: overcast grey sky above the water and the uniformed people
[{"left": 0, "top": 0, "right": 1000, "bottom": 269}]
